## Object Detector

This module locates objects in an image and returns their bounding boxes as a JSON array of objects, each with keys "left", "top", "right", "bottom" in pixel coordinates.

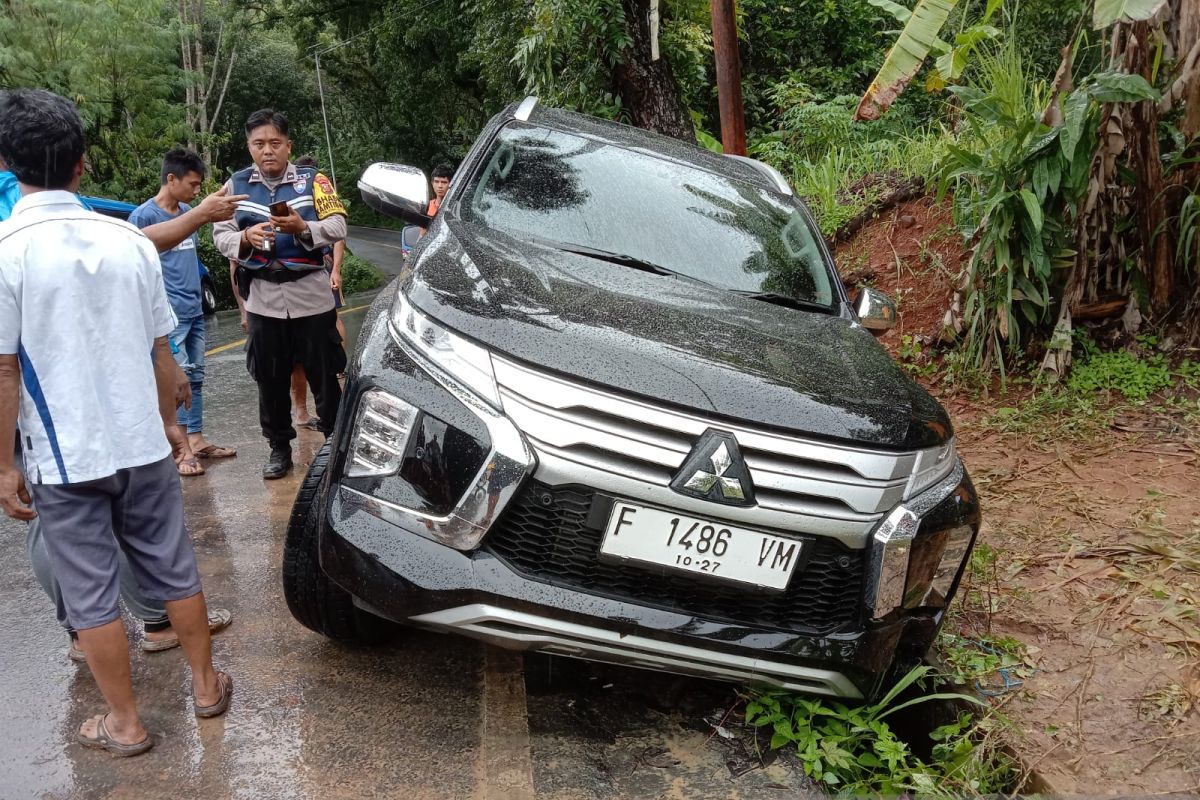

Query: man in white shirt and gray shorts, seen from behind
[{"left": 0, "top": 90, "right": 233, "bottom": 756}]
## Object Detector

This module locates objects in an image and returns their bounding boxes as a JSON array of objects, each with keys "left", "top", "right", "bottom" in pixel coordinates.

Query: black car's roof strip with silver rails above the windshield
[{"left": 504, "top": 98, "right": 791, "bottom": 194}]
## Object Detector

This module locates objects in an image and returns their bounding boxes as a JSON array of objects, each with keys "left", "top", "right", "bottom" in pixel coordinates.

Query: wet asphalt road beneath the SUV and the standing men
[{"left": 0, "top": 280, "right": 804, "bottom": 800}]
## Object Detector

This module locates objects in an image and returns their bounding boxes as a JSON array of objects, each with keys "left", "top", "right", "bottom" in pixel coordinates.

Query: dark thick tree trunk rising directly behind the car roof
[{"left": 612, "top": 0, "right": 696, "bottom": 142}]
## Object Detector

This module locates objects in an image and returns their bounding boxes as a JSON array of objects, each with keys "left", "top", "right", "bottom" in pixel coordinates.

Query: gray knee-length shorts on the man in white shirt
[{"left": 29, "top": 457, "right": 200, "bottom": 631}]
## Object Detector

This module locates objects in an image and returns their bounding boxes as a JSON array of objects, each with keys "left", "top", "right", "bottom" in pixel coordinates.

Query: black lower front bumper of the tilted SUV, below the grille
[{"left": 320, "top": 492, "right": 940, "bottom": 698}]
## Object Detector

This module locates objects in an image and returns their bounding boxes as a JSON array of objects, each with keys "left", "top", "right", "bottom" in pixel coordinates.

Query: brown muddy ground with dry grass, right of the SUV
[{"left": 949, "top": 419, "right": 1200, "bottom": 795}]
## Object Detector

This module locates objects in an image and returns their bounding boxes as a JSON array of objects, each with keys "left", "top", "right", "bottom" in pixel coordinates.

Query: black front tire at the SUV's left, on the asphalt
[{"left": 283, "top": 441, "right": 390, "bottom": 644}]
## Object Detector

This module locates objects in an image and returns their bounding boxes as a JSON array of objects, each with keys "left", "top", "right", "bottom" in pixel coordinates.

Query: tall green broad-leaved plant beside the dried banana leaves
[{"left": 940, "top": 31, "right": 1156, "bottom": 379}]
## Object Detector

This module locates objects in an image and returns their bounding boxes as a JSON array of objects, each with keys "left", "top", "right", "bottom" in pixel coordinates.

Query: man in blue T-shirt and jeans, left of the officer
[{"left": 130, "top": 148, "right": 236, "bottom": 475}]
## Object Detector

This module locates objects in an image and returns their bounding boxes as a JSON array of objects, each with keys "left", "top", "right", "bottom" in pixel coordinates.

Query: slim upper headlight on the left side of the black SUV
[{"left": 391, "top": 291, "right": 502, "bottom": 410}]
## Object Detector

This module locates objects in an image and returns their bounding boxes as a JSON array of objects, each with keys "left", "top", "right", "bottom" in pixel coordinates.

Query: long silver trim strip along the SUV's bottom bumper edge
[{"left": 409, "top": 603, "right": 862, "bottom": 699}]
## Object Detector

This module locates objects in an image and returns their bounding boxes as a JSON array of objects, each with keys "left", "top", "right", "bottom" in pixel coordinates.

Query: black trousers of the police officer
[{"left": 246, "top": 309, "right": 346, "bottom": 447}]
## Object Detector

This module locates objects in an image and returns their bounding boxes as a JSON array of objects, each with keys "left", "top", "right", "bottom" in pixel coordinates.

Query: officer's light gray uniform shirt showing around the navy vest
[{"left": 212, "top": 162, "right": 346, "bottom": 319}]
